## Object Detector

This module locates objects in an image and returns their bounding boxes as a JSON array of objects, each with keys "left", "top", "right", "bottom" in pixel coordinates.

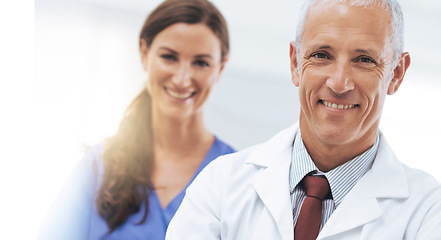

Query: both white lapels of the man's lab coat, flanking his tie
[{"left": 246, "top": 123, "right": 409, "bottom": 239}]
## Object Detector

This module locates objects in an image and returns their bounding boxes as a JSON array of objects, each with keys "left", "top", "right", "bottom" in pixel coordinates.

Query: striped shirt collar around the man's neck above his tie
[{"left": 289, "top": 129, "right": 379, "bottom": 207}]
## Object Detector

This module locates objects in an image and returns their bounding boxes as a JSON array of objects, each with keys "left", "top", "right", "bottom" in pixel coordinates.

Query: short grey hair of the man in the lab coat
[{"left": 295, "top": 0, "right": 404, "bottom": 62}]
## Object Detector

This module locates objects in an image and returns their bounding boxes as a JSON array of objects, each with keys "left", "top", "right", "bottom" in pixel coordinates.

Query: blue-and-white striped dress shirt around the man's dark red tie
[{"left": 289, "top": 129, "right": 379, "bottom": 230}]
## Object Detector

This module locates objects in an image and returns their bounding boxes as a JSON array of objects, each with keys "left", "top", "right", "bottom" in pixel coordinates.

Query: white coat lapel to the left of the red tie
[{"left": 247, "top": 124, "right": 297, "bottom": 239}]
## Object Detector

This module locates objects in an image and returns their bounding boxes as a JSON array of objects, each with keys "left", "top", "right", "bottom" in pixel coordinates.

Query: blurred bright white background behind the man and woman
[{"left": 0, "top": 0, "right": 441, "bottom": 239}]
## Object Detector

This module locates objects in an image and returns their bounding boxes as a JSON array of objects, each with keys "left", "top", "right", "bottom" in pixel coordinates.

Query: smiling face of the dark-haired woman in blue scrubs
[{"left": 141, "top": 23, "right": 225, "bottom": 119}]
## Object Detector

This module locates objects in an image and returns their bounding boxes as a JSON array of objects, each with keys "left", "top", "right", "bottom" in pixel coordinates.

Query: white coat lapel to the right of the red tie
[{"left": 317, "top": 133, "right": 409, "bottom": 239}]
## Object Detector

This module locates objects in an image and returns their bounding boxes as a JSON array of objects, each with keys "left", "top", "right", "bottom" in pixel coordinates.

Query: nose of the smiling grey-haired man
[{"left": 326, "top": 62, "right": 354, "bottom": 94}]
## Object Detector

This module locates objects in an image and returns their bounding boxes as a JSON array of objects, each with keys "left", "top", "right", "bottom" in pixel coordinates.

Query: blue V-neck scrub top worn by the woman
[{"left": 37, "top": 138, "right": 234, "bottom": 240}]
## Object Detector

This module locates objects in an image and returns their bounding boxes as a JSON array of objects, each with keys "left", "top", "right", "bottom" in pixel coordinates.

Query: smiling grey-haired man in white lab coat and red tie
[{"left": 166, "top": 0, "right": 441, "bottom": 240}]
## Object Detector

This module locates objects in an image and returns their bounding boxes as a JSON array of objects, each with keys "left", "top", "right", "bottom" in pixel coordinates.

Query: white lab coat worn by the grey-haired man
[{"left": 166, "top": 124, "right": 441, "bottom": 240}]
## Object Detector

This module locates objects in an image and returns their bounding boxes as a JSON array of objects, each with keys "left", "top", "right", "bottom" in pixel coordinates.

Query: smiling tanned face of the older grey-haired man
[{"left": 290, "top": 3, "right": 408, "bottom": 158}]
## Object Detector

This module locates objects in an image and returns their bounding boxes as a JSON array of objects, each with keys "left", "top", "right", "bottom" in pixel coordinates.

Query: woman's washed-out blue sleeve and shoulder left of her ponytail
[{"left": 37, "top": 143, "right": 104, "bottom": 240}]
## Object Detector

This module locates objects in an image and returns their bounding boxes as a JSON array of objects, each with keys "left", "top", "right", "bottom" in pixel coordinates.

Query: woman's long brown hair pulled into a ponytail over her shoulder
[{"left": 95, "top": 0, "right": 229, "bottom": 233}]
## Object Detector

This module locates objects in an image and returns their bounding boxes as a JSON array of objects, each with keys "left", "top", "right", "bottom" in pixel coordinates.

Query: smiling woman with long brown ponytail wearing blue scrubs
[{"left": 38, "top": 0, "right": 233, "bottom": 239}]
